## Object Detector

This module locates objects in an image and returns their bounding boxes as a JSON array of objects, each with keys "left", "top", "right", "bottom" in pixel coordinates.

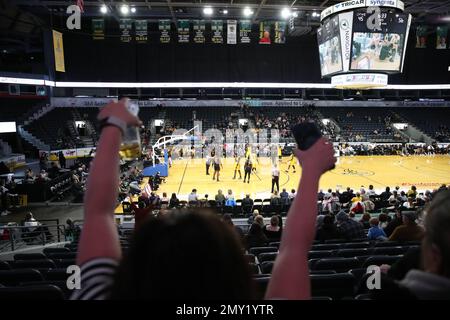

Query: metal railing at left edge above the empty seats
[{"left": 0, "top": 219, "right": 68, "bottom": 252}]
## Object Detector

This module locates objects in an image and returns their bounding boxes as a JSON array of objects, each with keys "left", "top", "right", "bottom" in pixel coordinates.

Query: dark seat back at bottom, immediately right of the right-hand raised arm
[{"left": 310, "top": 273, "right": 355, "bottom": 299}]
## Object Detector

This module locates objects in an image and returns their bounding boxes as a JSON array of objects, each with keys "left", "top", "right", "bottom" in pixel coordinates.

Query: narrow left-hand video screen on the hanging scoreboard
[{"left": 317, "top": 16, "right": 343, "bottom": 77}]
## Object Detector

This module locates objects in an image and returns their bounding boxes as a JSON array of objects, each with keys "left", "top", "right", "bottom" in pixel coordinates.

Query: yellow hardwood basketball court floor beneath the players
[{"left": 116, "top": 156, "right": 450, "bottom": 213}]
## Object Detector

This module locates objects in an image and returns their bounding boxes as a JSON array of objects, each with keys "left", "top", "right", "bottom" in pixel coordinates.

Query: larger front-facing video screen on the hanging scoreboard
[{"left": 350, "top": 11, "right": 409, "bottom": 72}]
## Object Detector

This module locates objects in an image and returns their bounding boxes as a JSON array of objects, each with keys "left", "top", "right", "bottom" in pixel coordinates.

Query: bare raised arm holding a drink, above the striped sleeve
[{"left": 77, "top": 99, "right": 140, "bottom": 265}]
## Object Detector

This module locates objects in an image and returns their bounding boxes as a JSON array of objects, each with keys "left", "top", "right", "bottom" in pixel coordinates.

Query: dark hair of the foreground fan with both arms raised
[{"left": 111, "top": 210, "right": 253, "bottom": 300}]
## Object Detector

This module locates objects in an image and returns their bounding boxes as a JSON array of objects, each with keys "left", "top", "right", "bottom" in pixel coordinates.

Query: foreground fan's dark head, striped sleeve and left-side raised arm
[{"left": 71, "top": 99, "right": 253, "bottom": 300}]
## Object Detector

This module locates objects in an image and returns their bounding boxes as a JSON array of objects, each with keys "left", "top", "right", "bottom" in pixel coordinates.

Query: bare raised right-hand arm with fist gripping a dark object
[{"left": 266, "top": 138, "right": 336, "bottom": 300}]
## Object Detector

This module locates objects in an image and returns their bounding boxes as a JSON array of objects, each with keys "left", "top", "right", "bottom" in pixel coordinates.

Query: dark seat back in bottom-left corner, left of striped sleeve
[{"left": 0, "top": 284, "right": 64, "bottom": 302}]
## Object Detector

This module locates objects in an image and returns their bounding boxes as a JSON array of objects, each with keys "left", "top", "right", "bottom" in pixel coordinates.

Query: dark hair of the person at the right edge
[{"left": 423, "top": 191, "right": 450, "bottom": 278}]
